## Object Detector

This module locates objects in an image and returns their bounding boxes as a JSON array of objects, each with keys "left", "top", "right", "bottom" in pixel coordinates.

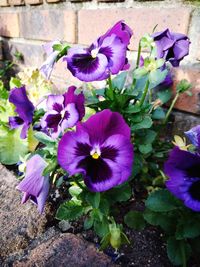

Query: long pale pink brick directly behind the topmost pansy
[{"left": 78, "top": 7, "right": 191, "bottom": 50}]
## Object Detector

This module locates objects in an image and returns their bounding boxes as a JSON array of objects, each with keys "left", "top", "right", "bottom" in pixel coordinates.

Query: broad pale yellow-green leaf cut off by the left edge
[{"left": 0, "top": 126, "right": 28, "bottom": 165}]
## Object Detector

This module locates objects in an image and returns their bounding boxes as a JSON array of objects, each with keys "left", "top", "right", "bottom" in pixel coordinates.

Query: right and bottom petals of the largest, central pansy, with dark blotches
[{"left": 82, "top": 135, "right": 133, "bottom": 192}]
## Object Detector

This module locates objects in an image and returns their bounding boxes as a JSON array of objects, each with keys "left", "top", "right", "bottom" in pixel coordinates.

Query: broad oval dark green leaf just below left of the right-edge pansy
[{"left": 145, "top": 189, "right": 180, "bottom": 212}]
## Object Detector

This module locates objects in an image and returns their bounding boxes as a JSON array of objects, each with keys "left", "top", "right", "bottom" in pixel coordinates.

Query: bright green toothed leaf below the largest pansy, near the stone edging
[{"left": 56, "top": 200, "right": 84, "bottom": 220}]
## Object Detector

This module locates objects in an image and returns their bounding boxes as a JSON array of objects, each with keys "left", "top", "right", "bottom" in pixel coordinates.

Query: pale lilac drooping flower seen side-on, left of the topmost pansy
[{"left": 40, "top": 41, "right": 60, "bottom": 79}]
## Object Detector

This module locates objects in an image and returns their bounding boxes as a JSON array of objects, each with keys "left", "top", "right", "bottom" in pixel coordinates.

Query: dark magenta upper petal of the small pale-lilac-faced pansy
[{"left": 63, "top": 86, "right": 85, "bottom": 121}]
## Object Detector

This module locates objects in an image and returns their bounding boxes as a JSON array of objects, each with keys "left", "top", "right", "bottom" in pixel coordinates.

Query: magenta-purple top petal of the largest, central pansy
[{"left": 78, "top": 109, "right": 131, "bottom": 146}]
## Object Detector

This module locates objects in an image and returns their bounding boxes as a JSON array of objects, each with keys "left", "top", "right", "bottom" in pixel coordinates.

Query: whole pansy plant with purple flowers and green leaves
[{"left": 0, "top": 21, "right": 200, "bottom": 266}]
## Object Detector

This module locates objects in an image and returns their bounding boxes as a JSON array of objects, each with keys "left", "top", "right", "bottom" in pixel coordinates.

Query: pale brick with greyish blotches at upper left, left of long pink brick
[{"left": 20, "top": 9, "right": 76, "bottom": 43}]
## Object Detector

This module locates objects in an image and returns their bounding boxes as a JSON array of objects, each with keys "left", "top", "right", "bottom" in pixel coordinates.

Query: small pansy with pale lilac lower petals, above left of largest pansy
[{"left": 41, "top": 86, "right": 85, "bottom": 138}]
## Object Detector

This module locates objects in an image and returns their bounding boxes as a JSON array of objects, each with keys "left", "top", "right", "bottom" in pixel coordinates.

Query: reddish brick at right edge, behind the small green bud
[{"left": 174, "top": 68, "right": 200, "bottom": 114}]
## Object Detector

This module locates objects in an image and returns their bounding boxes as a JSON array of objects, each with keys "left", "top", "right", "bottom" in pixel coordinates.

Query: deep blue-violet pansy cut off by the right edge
[{"left": 165, "top": 126, "right": 200, "bottom": 211}]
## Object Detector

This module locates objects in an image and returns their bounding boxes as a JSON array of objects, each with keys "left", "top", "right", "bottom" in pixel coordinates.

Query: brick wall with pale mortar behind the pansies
[{"left": 0, "top": 0, "right": 200, "bottom": 118}]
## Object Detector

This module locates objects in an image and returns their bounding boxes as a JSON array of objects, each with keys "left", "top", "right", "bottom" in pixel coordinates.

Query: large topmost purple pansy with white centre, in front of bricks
[{"left": 63, "top": 21, "right": 132, "bottom": 82}]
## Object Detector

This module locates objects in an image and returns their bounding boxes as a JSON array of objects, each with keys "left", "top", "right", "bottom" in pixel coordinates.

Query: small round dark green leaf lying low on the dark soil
[{"left": 124, "top": 211, "right": 145, "bottom": 231}]
